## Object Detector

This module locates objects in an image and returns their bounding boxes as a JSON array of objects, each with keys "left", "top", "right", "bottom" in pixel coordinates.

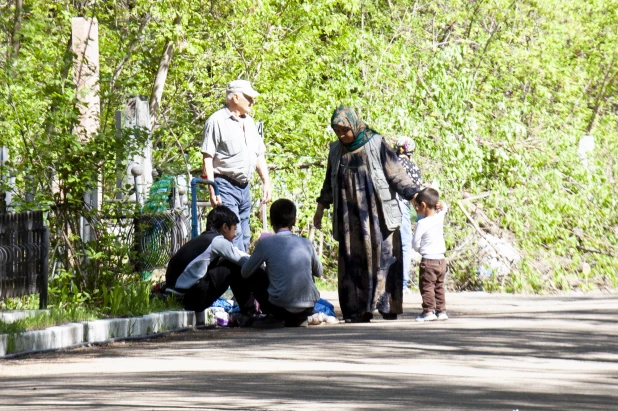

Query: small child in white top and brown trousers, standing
[{"left": 412, "top": 188, "right": 448, "bottom": 322}]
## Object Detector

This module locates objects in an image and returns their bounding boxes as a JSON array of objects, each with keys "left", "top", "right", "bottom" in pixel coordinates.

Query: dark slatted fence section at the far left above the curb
[{"left": 0, "top": 211, "right": 49, "bottom": 308}]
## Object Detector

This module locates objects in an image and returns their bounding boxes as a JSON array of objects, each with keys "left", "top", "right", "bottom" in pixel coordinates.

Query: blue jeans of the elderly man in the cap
[{"left": 215, "top": 177, "right": 251, "bottom": 252}]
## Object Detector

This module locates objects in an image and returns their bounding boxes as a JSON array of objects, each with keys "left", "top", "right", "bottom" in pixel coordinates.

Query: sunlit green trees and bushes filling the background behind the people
[{"left": 0, "top": 0, "right": 618, "bottom": 312}]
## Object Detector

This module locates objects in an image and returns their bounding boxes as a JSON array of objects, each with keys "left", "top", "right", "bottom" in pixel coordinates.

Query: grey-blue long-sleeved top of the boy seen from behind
[{"left": 241, "top": 231, "right": 322, "bottom": 308}]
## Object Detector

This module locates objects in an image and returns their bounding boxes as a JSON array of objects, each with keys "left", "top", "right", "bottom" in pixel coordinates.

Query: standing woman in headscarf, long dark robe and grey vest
[{"left": 313, "top": 106, "right": 420, "bottom": 322}]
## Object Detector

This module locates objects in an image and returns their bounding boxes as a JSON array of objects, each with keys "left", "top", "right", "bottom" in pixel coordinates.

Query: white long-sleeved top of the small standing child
[{"left": 412, "top": 202, "right": 448, "bottom": 260}]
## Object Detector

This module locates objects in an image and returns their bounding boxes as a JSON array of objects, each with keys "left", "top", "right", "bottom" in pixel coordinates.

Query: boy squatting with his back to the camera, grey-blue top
[{"left": 241, "top": 199, "right": 322, "bottom": 328}]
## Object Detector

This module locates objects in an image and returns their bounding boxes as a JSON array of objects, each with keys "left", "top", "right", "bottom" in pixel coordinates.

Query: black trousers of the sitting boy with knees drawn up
[{"left": 183, "top": 259, "right": 259, "bottom": 314}]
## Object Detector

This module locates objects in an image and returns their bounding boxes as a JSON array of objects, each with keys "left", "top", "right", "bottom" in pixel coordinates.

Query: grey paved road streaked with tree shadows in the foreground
[{"left": 0, "top": 293, "right": 618, "bottom": 411}]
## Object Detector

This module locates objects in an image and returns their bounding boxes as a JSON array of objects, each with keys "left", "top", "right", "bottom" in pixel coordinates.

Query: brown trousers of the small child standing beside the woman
[{"left": 418, "top": 258, "right": 446, "bottom": 312}]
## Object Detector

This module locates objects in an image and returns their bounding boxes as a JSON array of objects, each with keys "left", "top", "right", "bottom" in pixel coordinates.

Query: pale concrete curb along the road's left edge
[{"left": 0, "top": 309, "right": 215, "bottom": 358}]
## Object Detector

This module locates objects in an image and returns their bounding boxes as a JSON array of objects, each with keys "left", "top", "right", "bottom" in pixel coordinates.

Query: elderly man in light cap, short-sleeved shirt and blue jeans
[{"left": 201, "top": 80, "right": 271, "bottom": 252}]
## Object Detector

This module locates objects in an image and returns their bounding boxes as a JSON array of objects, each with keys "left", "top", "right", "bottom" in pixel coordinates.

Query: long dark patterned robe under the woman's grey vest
[{"left": 317, "top": 135, "right": 419, "bottom": 319}]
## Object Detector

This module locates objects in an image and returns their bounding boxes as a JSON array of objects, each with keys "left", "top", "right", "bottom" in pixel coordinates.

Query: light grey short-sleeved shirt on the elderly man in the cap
[{"left": 201, "top": 107, "right": 266, "bottom": 183}]
